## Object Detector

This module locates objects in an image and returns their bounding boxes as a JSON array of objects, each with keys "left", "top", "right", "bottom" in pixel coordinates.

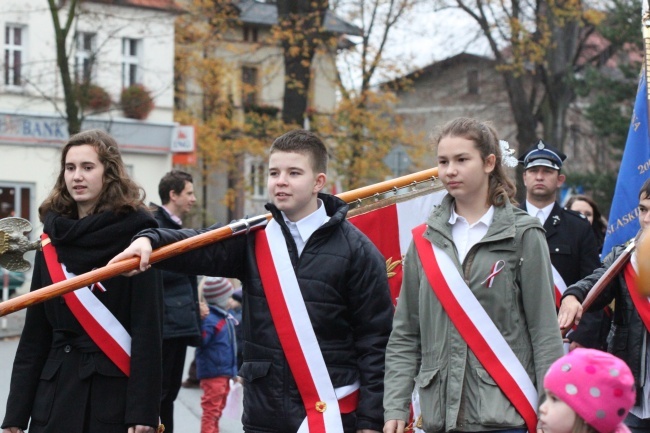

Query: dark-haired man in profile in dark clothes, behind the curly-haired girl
[{"left": 149, "top": 170, "right": 201, "bottom": 433}]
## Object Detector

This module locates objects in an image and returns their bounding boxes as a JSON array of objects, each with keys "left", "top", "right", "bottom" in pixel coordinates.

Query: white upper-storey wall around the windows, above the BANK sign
[{"left": 0, "top": 0, "right": 175, "bottom": 122}]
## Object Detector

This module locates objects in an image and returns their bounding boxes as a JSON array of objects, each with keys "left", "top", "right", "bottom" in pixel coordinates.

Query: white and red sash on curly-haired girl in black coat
[{"left": 41, "top": 233, "right": 131, "bottom": 376}]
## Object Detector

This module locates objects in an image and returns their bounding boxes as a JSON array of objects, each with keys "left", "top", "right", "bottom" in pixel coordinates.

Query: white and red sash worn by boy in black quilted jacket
[{"left": 255, "top": 220, "right": 359, "bottom": 433}]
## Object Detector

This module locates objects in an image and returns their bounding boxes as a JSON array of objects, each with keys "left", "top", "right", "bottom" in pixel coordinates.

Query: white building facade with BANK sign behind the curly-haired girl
[{"left": 0, "top": 0, "right": 179, "bottom": 226}]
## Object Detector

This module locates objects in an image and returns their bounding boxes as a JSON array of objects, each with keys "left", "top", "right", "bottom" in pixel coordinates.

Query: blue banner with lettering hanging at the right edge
[{"left": 602, "top": 71, "right": 650, "bottom": 253}]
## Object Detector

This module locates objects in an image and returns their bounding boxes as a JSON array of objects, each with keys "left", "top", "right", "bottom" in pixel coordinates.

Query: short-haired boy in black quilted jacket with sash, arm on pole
[{"left": 112, "top": 130, "right": 393, "bottom": 432}]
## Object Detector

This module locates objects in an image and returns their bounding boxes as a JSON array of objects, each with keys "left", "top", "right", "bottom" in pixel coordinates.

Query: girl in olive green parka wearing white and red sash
[{"left": 384, "top": 118, "right": 562, "bottom": 433}]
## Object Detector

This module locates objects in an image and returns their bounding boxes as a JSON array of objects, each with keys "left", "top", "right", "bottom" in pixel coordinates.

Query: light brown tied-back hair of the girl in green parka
[{"left": 433, "top": 117, "right": 517, "bottom": 206}]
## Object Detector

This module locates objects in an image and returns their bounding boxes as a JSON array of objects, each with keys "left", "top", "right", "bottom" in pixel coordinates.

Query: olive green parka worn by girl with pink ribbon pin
[{"left": 384, "top": 195, "right": 563, "bottom": 433}]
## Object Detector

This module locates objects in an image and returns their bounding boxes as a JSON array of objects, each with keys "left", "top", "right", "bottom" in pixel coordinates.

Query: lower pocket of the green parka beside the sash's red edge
[{"left": 476, "top": 367, "right": 524, "bottom": 428}]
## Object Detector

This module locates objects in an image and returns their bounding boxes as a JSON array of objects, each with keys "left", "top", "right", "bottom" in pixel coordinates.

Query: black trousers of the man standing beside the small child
[{"left": 160, "top": 338, "right": 187, "bottom": 433}]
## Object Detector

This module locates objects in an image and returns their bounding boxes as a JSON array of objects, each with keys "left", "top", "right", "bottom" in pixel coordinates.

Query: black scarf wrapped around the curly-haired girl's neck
[{"left": 43, "top": 210, "right": 158, "bottom": 275}]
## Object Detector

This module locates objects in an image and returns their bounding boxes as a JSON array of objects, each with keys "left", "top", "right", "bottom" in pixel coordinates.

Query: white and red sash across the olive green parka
[{"left": 413, "top": 224, "right": 537, "bottom": 433}]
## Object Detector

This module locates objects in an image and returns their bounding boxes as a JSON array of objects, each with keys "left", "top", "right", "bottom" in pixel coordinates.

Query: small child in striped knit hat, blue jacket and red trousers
[{"left": 196, "top": 277, "right": 237, "bottom": 433}]
